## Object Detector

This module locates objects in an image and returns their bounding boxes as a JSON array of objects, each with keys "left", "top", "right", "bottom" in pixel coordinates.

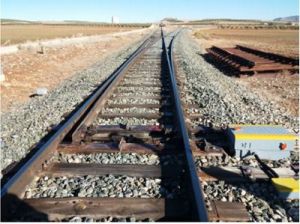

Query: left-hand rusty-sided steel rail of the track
[{"left": 1, "top": 36, "right": 156, "bottom": 199}]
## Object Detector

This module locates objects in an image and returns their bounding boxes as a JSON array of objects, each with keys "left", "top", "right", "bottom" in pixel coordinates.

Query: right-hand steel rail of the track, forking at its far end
[{"left": 161, "top": 30, "right": 208, "bottom": 222}]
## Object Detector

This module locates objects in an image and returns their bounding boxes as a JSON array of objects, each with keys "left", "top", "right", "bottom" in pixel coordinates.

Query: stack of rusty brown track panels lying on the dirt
[{"left": 206, "top": 45, "right": 299, "bottom": 76}]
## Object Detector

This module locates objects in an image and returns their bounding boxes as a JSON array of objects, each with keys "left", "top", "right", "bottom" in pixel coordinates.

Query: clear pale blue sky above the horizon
[{"left": 0, "top": 0, "right": 299, "bottom": 22}]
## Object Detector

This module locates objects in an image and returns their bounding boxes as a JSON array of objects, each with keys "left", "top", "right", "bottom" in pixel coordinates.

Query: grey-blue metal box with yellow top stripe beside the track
[{"left": 226, "top": 124, "right": 297, "bottom": 160}]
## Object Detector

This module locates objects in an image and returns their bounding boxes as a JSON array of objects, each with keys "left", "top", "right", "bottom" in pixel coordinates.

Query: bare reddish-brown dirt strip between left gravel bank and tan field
[{"left": 0, "top": 34, "right": 142, "bottom": 113}]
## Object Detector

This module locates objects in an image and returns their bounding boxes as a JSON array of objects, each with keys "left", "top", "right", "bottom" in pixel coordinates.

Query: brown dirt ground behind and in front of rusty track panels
[{"left": 193, "top": 29, "right": 299, "bottom": 116}]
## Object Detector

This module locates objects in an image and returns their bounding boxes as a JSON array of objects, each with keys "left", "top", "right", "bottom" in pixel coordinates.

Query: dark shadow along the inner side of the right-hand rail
[{"left": 158, "top": 37, "right": 203, "bottom": 222}]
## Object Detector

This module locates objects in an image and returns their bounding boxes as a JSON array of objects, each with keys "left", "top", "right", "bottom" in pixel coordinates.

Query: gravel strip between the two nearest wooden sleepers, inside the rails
[{"left": 25, "top": 175, "right": 181, "bottom": 198}]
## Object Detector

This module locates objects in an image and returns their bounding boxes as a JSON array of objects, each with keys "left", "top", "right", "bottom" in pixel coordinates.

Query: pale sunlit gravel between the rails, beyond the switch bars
[{"left": 93, "top": 41, "right": 163, "bottom": 128}]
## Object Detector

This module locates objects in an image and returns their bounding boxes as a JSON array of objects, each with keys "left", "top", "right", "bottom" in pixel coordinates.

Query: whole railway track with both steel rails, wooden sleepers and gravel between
[{"left": 1, "top": 28, "right": 208, "bottom": 221}]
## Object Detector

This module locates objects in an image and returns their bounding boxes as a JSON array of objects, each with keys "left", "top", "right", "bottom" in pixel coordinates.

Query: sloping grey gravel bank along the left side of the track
[{"left": 1, "top": 36, "right": 148, "bottom": 170}]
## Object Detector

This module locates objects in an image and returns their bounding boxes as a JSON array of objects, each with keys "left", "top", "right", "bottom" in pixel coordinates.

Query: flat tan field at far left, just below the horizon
[{"left": 1, "top": 24, "right": 141, "bottom": 45}]
